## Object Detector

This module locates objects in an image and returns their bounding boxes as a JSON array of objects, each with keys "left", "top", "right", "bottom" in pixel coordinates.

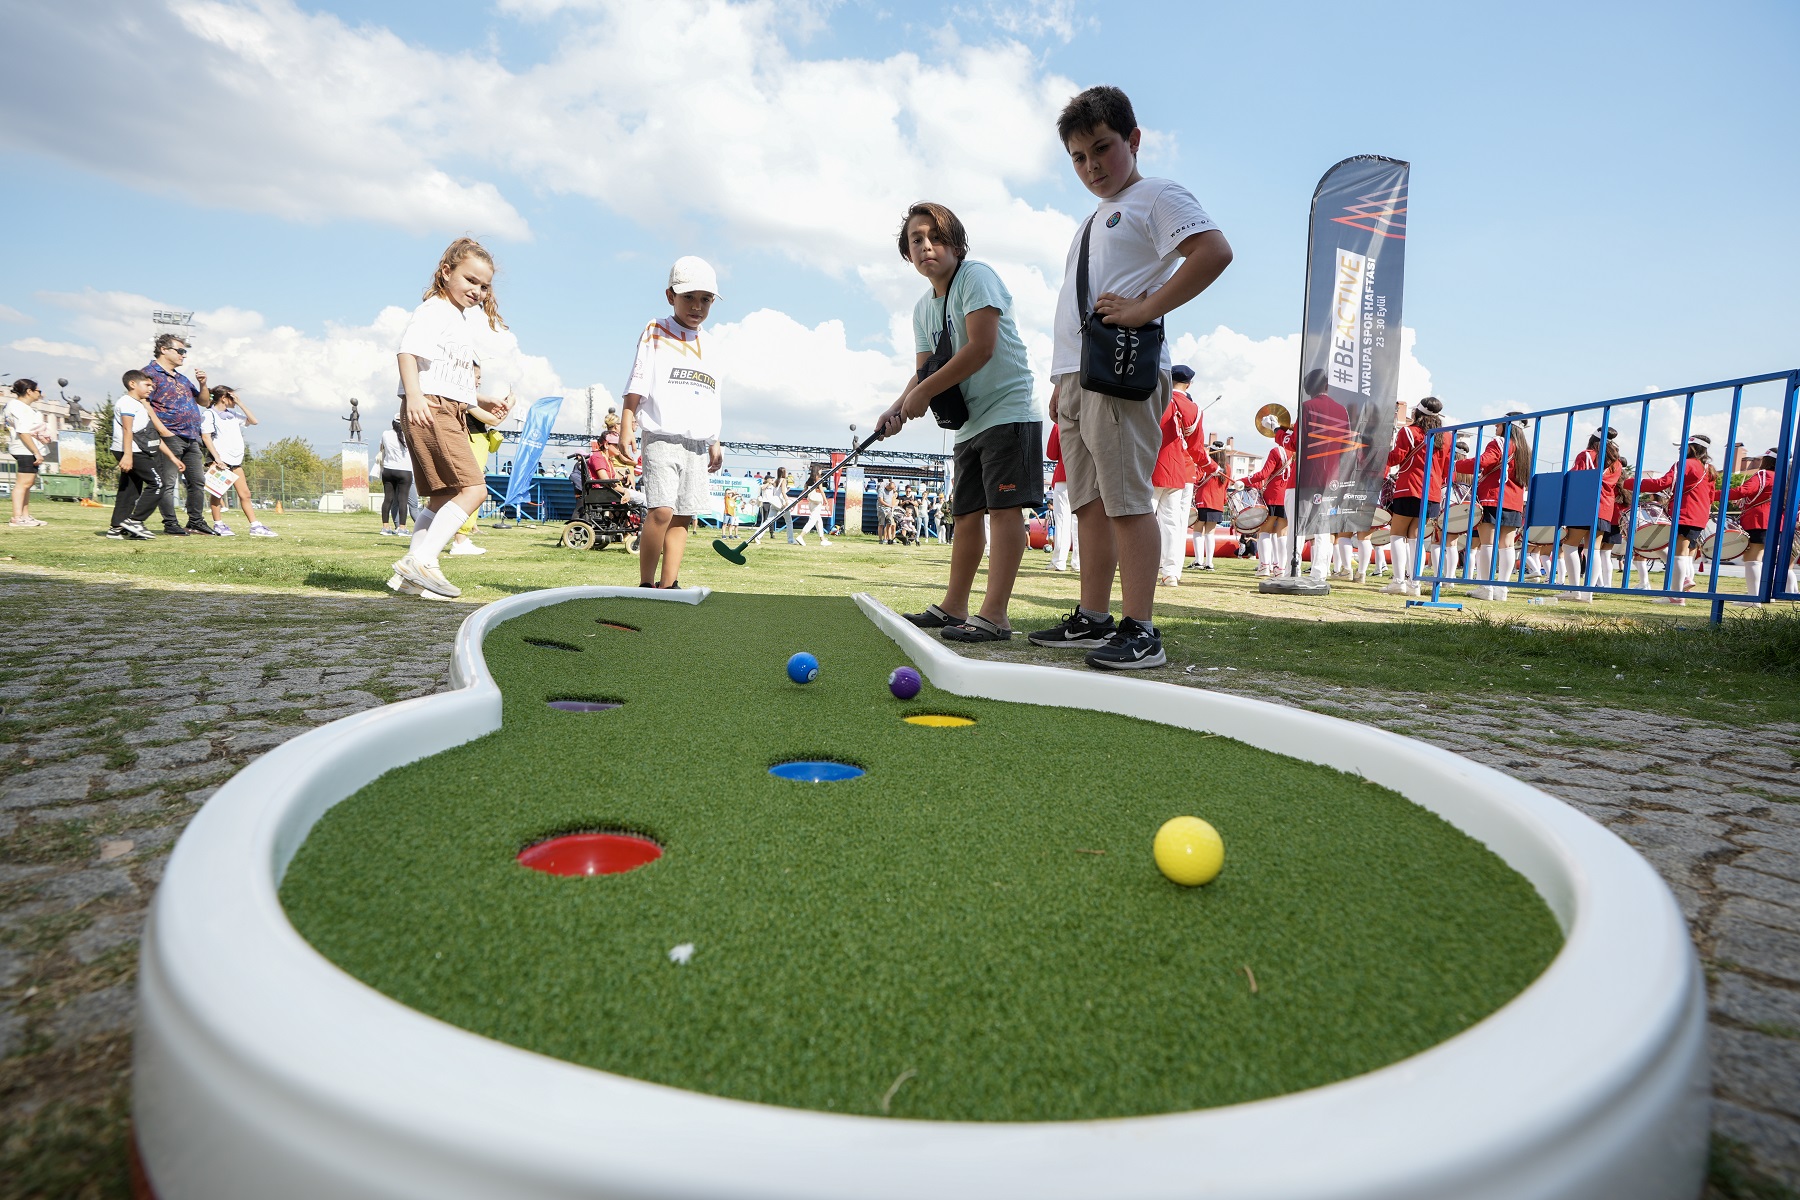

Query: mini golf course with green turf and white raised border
[{"left": 133, "top": 587, "right": 1708, "bottom": 1200}]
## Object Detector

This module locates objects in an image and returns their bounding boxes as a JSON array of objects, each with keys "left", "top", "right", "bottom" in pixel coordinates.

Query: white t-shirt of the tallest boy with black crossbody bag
[{"left": 1049, "top": 180, "right": 1219, "bottom": 378}]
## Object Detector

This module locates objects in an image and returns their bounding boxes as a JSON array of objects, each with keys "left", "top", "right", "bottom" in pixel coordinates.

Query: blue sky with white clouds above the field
[{"left": 0, "top": 0, "right": 1800, "bottom": 464}]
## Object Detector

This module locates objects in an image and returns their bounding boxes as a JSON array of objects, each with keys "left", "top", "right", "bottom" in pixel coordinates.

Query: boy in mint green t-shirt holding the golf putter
[{"left": 877, "top": 201, "right": 1044, "bottom": 642}]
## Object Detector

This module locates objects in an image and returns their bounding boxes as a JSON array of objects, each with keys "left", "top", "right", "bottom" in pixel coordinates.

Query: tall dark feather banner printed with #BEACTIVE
[{"left": 1292, "top": 155, "right": 1411, "bottom": 549}]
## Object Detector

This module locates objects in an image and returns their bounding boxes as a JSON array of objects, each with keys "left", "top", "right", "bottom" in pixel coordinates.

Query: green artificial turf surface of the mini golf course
[{"left": 281, "top": 594, "right": 1562, "bottom": 1121}]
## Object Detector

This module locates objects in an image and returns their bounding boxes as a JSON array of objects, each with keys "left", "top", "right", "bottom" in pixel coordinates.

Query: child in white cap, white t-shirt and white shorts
[{"left": 619, "top": 255, "right": 725, "bottom": 588}]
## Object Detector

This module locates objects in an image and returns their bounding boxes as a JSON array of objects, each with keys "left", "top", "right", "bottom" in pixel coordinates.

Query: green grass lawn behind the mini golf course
[{"left": 0, "top": 504, "right": 1800, "bottom": 725}]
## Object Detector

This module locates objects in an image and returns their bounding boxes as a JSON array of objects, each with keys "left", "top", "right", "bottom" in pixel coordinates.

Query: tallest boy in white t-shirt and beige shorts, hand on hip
[{"left": 1031, "top": 86, "right": 1231, "bottom": 669}]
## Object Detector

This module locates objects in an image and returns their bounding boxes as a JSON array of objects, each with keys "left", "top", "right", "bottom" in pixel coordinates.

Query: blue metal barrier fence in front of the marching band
[{"left": 1408, "top": 369, "right": 1800, "bottom": 621}]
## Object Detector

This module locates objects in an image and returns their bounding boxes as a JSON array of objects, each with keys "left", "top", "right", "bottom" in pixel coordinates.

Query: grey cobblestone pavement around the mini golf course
[{"left": 0, "top": 570, "right": 1800, "bottom": 1196}]
